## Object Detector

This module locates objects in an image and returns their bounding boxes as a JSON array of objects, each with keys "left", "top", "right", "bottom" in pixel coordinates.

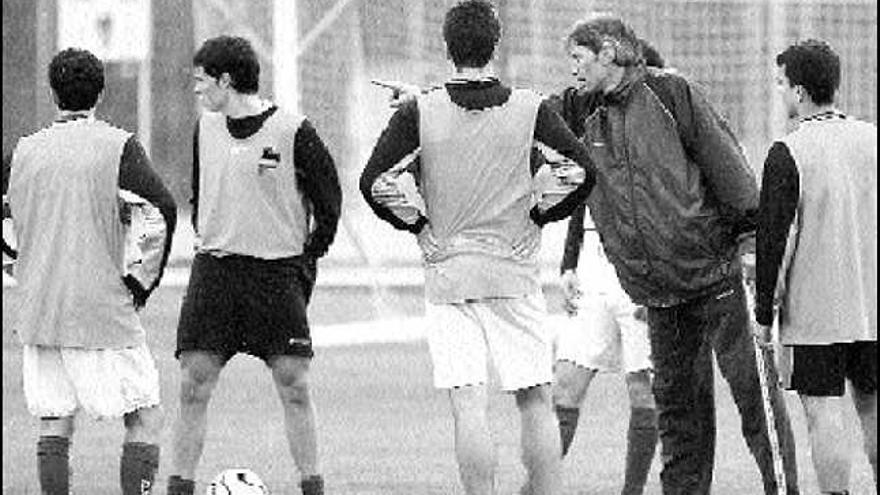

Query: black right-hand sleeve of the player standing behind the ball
[{"left": 293, "top": 120, "right": 342, "bottom": 258}]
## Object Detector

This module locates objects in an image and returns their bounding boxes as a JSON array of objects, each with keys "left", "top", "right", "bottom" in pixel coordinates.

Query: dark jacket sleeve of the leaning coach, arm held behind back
[{"left": 665, "top": 75, "right": 758, "bottom": 235}]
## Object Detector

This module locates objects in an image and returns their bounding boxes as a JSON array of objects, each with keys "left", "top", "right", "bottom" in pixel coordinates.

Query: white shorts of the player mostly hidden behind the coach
[{"left": 554, "top": 290, "right": 653, "bottom": 373}]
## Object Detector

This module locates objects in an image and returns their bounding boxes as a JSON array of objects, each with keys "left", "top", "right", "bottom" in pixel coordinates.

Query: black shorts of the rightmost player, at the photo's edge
[{"left": 788, "top": 341, "right": 877, "bottom": 397}]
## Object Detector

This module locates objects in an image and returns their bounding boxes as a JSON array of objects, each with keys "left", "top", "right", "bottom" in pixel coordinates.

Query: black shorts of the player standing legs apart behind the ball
[{"left": 174, "top": 254, "right": 316, "bottom": 364}]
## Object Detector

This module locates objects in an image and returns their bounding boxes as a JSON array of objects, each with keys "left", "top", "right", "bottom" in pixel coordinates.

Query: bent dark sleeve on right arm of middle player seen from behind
[{"left": 530, "top": 101, "right": 596, "bottom": 225}]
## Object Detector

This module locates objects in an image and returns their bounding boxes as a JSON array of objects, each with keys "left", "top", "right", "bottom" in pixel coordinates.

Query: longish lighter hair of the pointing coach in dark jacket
[{"left": 567, "top": 15, "right": 642, "bottom": 66}]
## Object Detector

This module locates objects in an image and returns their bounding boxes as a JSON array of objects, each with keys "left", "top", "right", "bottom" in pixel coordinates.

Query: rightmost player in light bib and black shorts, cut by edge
[{"left": 755, "top": 40, "right": 877, "bottom": 494}]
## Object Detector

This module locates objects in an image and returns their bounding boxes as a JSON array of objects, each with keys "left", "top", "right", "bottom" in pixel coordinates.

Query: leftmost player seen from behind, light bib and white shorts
[{"left": 3, "top": 48, "right": 177, "bottom": 495}]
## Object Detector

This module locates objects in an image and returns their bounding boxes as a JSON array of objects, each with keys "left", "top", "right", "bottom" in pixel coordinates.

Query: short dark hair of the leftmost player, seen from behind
[{"left": 49, "top": 48, "right": 104, "bottom": 111}]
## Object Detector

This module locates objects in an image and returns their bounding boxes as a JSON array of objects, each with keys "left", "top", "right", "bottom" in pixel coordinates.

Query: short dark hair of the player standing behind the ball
[{"left": 193, "top": 36, "right": 260, "bottom": 94}]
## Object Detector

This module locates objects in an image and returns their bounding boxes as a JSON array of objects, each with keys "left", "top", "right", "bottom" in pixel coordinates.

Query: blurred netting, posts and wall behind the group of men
[{"left": 3, "top": 0, "right": 877, "bottom": 266}]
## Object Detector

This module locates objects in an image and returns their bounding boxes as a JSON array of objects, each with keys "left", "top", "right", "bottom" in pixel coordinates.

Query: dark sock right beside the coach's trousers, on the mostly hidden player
[{"left": 622, "top": 407, "right": 657, "bottom": 495}]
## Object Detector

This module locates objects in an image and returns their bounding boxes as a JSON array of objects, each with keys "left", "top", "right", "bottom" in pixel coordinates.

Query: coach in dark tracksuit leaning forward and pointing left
[{"left": 561, "top": 16, "right": 797, "bottom": 495}]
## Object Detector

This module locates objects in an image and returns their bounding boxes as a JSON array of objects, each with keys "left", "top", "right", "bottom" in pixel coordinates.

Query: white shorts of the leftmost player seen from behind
[{"left": 22, "top": 344, "right": 159, "bottom": 419}]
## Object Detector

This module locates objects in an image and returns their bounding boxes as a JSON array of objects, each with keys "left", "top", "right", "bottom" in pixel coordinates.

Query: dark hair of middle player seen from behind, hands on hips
[{"left": 443, "top": 0, "right": 501, "bottom": 67}]
